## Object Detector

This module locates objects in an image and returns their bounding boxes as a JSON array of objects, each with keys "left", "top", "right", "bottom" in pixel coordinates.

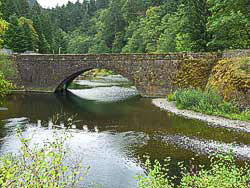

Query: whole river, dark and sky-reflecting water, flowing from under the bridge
[{"left": 0, "top": 74, "right": 250, "bottom": 188}]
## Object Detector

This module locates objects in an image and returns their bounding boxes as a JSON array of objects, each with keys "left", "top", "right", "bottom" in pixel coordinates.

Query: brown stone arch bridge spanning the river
[{"left": 13, "top": 53, "right": 218, "bottom": 96}]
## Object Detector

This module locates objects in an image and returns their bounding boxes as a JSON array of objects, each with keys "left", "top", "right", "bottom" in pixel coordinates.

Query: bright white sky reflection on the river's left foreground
[{"left": 1, "top": 125, "right": 147, "bottom": 188}]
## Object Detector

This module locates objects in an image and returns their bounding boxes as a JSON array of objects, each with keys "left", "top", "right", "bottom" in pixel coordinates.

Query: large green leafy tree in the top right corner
[{"left": 207, "top": 0, "right": 250, "bottom": 50}]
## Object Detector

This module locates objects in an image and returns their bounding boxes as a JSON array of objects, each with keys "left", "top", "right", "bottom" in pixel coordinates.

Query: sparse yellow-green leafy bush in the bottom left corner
[{"left": 0, "top": 131, "right": 87, "bottom": 188}]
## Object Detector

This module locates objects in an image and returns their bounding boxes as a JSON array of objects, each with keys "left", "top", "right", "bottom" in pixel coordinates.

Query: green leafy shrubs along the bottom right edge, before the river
[{"left": 136, "top": 153, "right": 250, "bottom": 188}]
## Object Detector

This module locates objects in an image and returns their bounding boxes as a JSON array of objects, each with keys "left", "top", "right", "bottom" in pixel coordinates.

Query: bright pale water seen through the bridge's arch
[{"left": 67, "top": 75, "right": 139, "bottom": 102}]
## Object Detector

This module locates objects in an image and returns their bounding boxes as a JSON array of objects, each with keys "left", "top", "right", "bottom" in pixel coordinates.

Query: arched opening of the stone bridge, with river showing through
[{"left": 56, "top": 68, "right": 140, "bottom": 102}]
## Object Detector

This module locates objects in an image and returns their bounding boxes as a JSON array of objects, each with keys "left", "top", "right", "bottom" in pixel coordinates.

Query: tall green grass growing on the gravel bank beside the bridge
[{"left": 168, "top": 89, "right": 250, "bottom": 121}]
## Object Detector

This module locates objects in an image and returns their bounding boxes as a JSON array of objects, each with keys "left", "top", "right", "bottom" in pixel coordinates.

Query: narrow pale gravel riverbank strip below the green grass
[{"left": 152, "top": 98, "right": 250, "bottom": 133}]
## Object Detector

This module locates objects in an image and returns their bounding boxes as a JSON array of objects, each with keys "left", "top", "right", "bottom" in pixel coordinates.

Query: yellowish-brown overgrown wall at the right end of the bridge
[{"left": 206, "top": 56, "right": 250, "bottom": 108}]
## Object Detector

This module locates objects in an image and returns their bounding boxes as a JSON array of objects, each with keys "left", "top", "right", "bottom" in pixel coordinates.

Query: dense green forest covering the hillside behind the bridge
[{"left": 0, "top": 0, "right": 250, "bottom": 53}]
